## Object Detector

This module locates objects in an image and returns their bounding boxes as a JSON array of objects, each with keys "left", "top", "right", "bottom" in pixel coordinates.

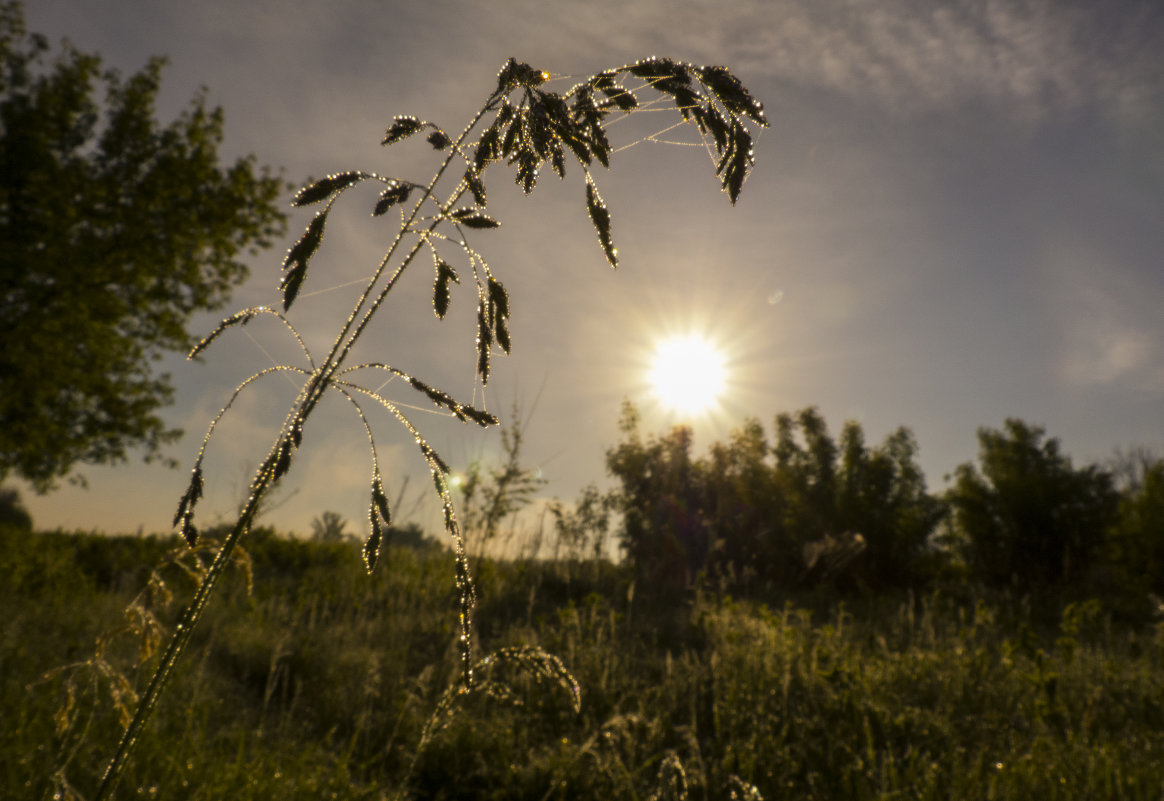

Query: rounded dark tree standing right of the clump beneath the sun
[{"left": 947, "top": 418, "right": 1119, "bottom": 586}]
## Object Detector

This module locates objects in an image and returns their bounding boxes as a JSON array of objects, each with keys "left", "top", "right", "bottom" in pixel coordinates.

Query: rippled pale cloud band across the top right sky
[{"left": 568, "top": 0, "right": 1164, "bottom": 120}]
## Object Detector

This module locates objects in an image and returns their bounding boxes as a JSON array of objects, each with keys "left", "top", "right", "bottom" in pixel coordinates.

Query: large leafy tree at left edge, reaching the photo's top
[{"left": 0, "top": 2, "right": 284, "bottom": 491}]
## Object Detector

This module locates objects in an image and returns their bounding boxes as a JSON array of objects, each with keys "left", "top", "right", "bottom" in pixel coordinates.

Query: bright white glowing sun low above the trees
[{"left": 648, "top": 334, "right": 725, "bottom": 416}]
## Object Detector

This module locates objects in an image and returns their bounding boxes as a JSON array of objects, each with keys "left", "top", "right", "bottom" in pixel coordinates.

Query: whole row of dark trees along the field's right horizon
[{"left": 595, "top": 404, "right": 1164, "bottom": 597}]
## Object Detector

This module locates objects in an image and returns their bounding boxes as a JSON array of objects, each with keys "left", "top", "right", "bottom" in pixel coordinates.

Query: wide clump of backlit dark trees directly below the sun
[{"left": 606, "top": 405, "right": 944, "bottom": 591}]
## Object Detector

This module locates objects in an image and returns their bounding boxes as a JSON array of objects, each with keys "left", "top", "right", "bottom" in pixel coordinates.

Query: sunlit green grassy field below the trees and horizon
[{"left": 0, "top": 521, "right": 1164, "bottom": 801}]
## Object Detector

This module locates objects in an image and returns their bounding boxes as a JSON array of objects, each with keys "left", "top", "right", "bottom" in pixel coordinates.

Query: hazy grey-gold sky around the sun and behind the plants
[{"left": 11, "top": 0, "right": 1164, "bottom": 544}]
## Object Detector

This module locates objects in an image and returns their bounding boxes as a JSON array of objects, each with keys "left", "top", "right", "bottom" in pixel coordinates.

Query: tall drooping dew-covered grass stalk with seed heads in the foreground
[{"left": 97, "top": 58, "right": 767, "bottom": 799}]
